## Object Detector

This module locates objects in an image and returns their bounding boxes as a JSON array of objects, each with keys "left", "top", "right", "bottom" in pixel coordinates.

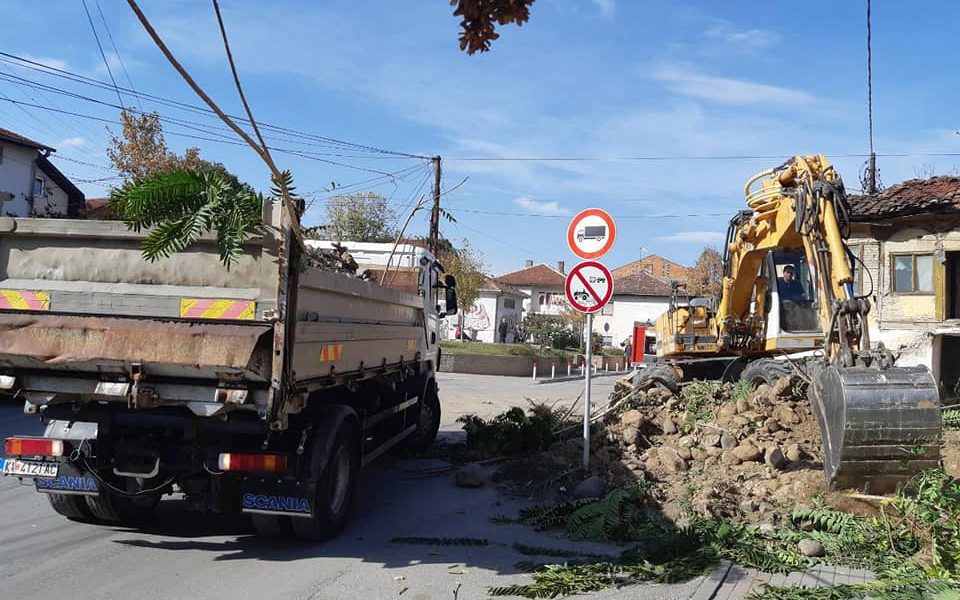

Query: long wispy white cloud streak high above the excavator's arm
[{"left": 653, "top": 65, "right": 817, "bottom": 106}]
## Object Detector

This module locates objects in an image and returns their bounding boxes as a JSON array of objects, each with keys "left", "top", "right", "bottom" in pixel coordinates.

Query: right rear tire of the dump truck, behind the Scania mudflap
[{"left": 290, "top": 422, "right": 360, "bottom": 541}]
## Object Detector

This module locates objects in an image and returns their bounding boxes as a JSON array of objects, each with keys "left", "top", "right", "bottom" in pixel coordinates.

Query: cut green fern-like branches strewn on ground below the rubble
[{"left": 490, "top": 470, "right": 960, "bottom": 600}]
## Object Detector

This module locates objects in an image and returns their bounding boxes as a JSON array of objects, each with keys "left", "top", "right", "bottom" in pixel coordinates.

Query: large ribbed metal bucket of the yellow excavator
[{"left": 810, "top": 366, "right": 941, "bottom": 494}]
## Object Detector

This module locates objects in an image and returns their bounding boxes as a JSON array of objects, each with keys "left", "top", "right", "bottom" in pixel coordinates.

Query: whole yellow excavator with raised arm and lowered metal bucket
[{"left": 652, "top": 155, "right": 941, "bottom": 494}]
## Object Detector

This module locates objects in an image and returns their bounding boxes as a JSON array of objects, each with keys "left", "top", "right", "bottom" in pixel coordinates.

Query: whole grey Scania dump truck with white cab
[{"left": 0, "top": 203, "right": 457, "bottom": 539}]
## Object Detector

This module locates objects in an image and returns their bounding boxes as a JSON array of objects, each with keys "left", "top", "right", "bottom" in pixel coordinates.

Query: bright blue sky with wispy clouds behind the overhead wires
[{"left": 0, "top": 0, "right": 960, "bottom": 273}]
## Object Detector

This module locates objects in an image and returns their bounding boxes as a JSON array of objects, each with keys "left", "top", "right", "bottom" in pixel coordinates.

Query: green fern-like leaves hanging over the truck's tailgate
[{"left": 110, "top": 170, "right": 263, "bottom": 268}]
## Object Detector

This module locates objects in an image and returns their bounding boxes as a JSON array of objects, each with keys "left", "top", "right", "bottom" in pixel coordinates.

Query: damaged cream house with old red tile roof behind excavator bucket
[{"left": 849, "top": 176, "right": 960, "bottom": 396}]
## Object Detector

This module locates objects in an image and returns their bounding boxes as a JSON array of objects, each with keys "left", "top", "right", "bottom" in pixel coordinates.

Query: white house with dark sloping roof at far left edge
[{"left": 0, "top": 128, "right": 84, "bottom": 217}]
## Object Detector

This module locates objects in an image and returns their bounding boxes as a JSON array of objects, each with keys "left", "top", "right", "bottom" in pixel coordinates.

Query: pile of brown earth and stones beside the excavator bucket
[{"left": 501, "top": 375, "right": 825, "bottom": 522}]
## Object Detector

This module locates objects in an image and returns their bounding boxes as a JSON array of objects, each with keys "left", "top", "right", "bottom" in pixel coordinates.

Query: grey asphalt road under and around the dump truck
[{"left": 0, "top": 374, "right": 709, "bottom": 600}]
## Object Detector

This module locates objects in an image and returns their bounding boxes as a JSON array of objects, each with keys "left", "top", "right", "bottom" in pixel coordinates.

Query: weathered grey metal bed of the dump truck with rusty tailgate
[{"left": 0, "top": 204, "right": 426, "bottom": 415}]
